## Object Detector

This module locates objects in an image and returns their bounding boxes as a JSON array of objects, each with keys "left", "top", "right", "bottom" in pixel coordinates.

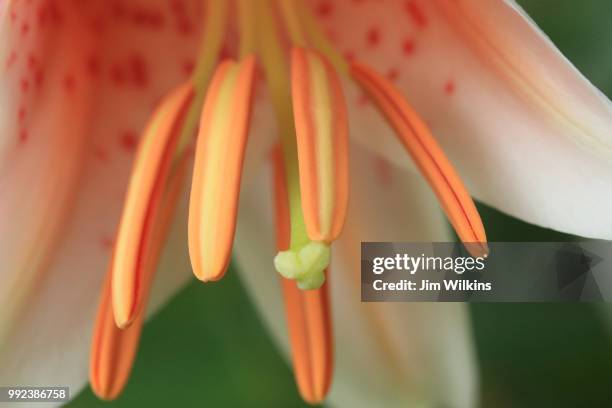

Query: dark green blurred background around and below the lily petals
[{"left": 69, "top": 0, "right": 612, "bottom": 408}]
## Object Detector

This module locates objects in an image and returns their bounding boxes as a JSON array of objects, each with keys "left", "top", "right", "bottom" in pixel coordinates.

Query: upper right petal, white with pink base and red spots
[{"left": 314, "top": 0, "right": 612, "bottom": 238}]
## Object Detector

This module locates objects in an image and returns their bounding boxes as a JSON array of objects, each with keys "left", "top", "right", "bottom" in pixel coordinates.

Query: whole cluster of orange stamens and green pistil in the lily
[{"left": 91, "top": 0, "right": 488, "bottom": 403}]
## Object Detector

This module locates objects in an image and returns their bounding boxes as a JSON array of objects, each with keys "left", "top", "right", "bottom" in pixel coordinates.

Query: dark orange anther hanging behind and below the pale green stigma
[{"left": 274, "top": 150, "right": 334, "bottom": 404}]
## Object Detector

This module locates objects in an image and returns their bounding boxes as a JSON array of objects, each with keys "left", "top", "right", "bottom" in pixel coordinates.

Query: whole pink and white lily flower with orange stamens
[{"left": 0, "top": 0, "right": 612, "bottom": 407}]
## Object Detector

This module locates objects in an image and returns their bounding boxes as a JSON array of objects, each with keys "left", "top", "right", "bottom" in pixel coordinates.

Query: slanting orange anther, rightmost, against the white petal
[{"left": 350, "top": 63, "right": 489, "bottom": 256}]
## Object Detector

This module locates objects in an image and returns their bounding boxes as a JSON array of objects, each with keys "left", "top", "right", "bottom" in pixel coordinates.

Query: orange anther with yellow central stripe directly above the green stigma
[{"left": 291, "top": 47, "right": 348, "bottom": 245}]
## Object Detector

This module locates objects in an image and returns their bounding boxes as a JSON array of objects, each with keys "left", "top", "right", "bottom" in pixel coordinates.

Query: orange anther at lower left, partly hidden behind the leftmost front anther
[{"left": 89, "top": 155, "right": 189, "bottom": 400}]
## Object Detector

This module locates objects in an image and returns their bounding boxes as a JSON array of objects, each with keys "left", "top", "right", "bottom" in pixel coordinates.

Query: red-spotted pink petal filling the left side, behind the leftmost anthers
[{"left": 0, "top": 0, "right": 201, "bottom": 395}]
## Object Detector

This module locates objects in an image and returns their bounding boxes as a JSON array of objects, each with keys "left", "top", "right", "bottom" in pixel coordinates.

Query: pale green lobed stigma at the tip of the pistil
[{"left": 274, "top": 242, "right": 331, "bottom": 290}]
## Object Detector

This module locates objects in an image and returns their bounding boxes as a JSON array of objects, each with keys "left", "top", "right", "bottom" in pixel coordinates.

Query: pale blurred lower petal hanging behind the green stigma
[{"left": 237, "top": 145, "right": 476, "bottom": 407}]
